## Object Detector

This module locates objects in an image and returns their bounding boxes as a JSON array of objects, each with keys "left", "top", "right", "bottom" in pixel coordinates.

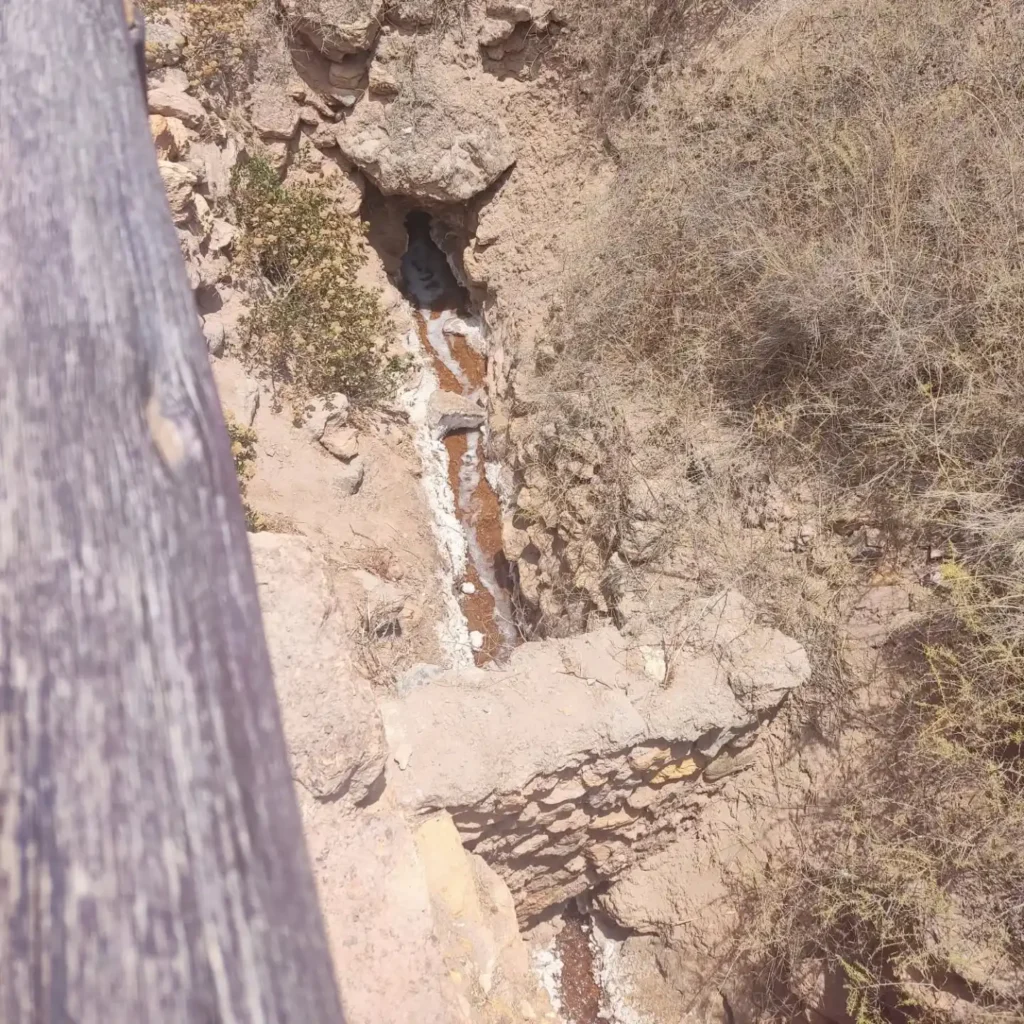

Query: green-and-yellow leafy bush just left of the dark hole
[{"left": 232, "top": 158, "right": 404, "bottom": 408}]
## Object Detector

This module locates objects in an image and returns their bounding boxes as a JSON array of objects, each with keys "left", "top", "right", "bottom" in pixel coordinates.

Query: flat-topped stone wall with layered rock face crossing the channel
[{"left": 382, "top": 592, "right": 810, "bottom": 920}]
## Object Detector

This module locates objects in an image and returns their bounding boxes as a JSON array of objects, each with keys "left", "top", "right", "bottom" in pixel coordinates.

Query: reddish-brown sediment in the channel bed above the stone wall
[{"left": 415, "top": 309, "right": 515, "bottom": 665}]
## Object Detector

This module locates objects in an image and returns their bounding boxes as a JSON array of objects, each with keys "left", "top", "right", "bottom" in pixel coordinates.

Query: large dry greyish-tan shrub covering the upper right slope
[{"left": 552, "top": 0, "right": 1024, "bottom": 528}]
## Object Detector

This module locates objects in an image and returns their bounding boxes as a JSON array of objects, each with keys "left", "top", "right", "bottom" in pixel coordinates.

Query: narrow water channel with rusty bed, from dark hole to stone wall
[{"left": 401, "top": 212, "right": 518, "bottom": 665}]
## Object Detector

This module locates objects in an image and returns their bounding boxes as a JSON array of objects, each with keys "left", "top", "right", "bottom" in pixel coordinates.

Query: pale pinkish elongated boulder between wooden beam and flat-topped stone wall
[{"left": 250, "top": 534, "right": 385, "bottom": 803}]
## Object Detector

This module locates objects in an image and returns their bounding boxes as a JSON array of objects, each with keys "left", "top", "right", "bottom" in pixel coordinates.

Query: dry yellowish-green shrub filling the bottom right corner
[{"left": 749, "top": 581, "right": 1024, "bottom": 1024}]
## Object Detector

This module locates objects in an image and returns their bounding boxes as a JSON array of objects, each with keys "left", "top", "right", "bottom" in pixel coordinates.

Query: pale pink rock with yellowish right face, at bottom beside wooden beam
[{"left": 300, "top": 793, "right": 553, "bottom": 1024}]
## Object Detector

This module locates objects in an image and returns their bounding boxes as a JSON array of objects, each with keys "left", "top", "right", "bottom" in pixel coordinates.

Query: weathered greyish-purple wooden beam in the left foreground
[{"left": 0, "top": 0, "right": 341, "bottom": 1024}]
